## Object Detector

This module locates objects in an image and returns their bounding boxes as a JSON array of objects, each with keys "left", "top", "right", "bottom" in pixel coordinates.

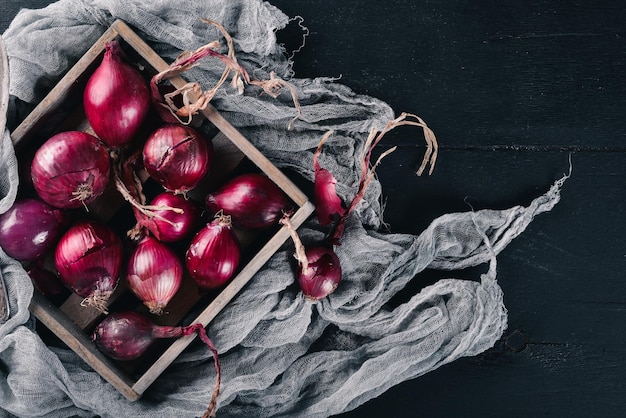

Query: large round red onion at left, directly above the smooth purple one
[{"left": 30, "top": 131, "right": 111, "bottom": 208}]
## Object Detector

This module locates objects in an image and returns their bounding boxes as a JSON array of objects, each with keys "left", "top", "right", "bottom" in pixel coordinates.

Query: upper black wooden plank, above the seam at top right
[{"left": 274, "top": 0, "right": 626, "bottom": 149}]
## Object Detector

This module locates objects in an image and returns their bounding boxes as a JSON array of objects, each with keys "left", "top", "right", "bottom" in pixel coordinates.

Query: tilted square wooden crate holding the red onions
[{"left": 11, "top": 20, "right": 314, "bottom": 401}]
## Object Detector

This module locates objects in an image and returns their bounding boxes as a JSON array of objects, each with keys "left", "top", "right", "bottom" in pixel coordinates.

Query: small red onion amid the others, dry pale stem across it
[{"left": 135, "top": 192, "right": 200, "bottom": 242}]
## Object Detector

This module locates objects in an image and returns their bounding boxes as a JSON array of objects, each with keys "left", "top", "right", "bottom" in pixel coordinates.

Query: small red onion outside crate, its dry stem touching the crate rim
[{"left": 280, "top": 214, "right": 341, "bottom": 301}]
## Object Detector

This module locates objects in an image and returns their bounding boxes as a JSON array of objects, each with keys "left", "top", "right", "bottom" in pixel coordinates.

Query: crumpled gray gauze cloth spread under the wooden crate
[{"left": 0, "top": 0, "right": 566, "bottom": 418}]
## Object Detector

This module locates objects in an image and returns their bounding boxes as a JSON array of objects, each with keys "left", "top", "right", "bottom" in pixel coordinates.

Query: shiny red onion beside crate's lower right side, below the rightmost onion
[{"left": 185, "top": 213, "right": 241, "bottom": 290}]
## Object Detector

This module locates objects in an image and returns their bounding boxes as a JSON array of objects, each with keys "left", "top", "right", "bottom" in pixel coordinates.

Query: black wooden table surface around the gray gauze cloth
[{"left": 0, "top": 0, "right": 626, "bottom": 418}]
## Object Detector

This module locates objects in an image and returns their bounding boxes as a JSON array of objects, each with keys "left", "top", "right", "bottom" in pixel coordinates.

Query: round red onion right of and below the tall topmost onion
[{"left": 142, "top": 124, "right": 213, "bottom": 194}]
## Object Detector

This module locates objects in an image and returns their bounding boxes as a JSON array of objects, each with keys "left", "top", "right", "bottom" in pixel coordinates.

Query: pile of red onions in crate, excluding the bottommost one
[{"left": 0, "top": 36, "right": 291, "bottom": 340}]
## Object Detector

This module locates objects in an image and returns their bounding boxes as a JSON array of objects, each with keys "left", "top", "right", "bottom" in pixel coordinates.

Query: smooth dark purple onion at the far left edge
[{"left": 0, "top": 199, "right": 68, "bottom": 261}]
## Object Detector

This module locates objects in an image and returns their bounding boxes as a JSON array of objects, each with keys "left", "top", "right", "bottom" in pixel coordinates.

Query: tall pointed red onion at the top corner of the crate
[{"left": 83, "top": 41, "right": 151, "bottom": 148}]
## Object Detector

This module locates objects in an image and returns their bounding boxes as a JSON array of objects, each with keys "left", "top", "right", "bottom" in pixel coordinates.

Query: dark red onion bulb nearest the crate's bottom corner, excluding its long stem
[{"left": 92, "top": 311, "right": 155, "bottom": 361}]
